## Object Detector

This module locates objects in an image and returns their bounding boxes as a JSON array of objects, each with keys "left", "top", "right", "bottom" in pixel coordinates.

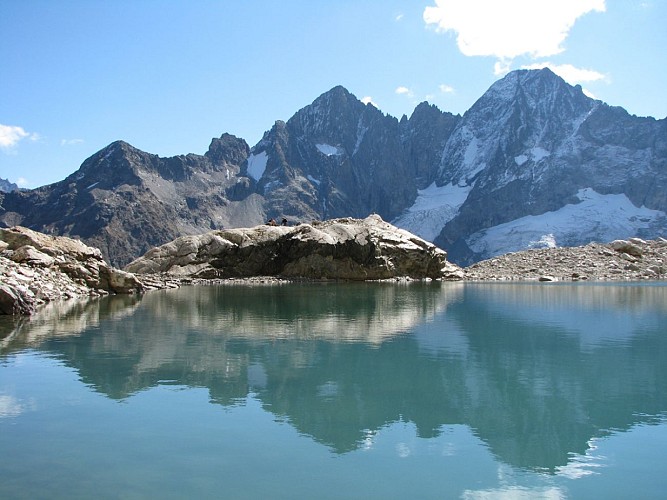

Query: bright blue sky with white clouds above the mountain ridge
[{"left": 0, "top": 0, "right": 667, "bottom": 188}]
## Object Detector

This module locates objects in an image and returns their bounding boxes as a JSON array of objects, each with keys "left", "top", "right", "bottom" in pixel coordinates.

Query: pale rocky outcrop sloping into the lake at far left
[{"left": 0, "top": 226, "right": 144, "bottom": 314}]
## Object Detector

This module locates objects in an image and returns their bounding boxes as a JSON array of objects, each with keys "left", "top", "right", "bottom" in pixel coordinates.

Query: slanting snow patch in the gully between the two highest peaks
[{"left": 392, "top": 182, "right": 472, "bottom": 241}]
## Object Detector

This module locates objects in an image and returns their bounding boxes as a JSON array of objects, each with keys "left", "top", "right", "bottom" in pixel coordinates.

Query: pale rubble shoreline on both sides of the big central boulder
[{"left": 0, "top": 223, "right": 667, "bottom": 315}]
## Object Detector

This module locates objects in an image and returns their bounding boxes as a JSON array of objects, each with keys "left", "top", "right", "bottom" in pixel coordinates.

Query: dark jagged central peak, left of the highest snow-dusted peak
[{"left": 246, "top": 87, "right": 456, "bottom": 224}]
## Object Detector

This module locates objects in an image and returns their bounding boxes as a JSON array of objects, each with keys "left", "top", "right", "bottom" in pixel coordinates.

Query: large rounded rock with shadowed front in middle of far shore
[{"left": 125, "top": 215, "right": 462, "bottom": 280}]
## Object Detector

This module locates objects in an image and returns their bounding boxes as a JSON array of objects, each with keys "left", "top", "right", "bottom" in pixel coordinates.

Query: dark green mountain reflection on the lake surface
[{"left": 0, "top": 283, "right": 667, "bottom": 473}]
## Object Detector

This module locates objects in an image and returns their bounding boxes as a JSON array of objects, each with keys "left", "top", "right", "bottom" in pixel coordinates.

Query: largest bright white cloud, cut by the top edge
[{"left": 423, "top": 0, "right": 605, "bottom": 60}]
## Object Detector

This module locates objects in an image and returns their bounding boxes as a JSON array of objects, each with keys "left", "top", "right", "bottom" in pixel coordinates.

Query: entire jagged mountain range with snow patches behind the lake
[{"left": 0, "top": 69, "right": 667, "bottom": 266}]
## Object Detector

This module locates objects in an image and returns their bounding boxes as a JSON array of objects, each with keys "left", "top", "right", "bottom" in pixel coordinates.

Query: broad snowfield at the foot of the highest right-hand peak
[{"left": 466, "top": 188, "right": 666, "bottom": 259}]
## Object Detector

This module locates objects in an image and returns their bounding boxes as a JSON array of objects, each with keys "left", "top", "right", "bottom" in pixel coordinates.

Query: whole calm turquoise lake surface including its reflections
[{"left": 0, "top": 283, "right": 667, "bottom": 499}]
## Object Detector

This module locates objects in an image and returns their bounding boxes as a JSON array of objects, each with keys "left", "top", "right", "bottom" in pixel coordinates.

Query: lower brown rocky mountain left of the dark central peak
[{"left": 0, "top": 134, "right": 253, "bottom": 266}]
